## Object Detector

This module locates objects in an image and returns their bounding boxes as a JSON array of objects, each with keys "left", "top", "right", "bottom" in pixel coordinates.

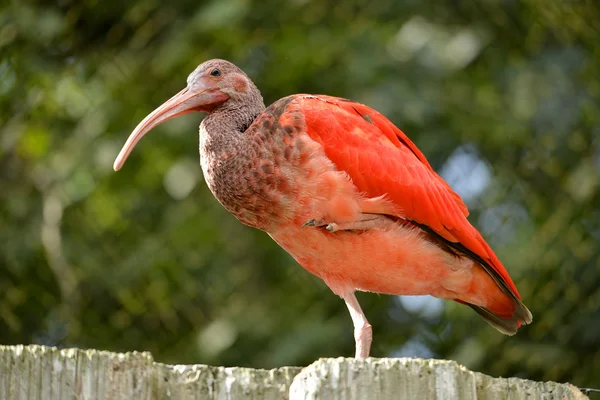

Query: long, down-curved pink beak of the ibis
[{"left": 113, "top": 81, "right": 229, "bottom": 171}]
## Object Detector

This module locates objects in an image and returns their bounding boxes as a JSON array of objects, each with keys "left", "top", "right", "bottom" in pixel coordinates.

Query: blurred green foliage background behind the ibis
[{"left": 0, "top": 0, "right": 600, "bottom": 387}]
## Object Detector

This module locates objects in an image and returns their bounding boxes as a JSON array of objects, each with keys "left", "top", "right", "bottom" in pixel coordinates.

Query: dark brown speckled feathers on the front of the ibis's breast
[{"left": 200, "top": 95, "right": 293, "bottom": 230}]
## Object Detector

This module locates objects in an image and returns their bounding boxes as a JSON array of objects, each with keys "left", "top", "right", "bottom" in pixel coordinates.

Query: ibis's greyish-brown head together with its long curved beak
[{"left": 113, "top": 59, "right": 264, "bottom": 171}]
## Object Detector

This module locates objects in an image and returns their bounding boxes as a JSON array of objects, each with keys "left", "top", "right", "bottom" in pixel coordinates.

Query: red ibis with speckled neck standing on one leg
[{"left": 113, "top": 59, "right": 532, "bottom": 358}]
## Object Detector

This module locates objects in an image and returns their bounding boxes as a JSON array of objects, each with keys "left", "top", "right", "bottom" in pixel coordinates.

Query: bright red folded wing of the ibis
[{"left": 294, "top": 96, "right": 519, "bottom": 297}]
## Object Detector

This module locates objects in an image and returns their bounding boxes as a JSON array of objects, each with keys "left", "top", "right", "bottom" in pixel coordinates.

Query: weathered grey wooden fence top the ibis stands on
[{"left": 0, "top": 346, "right": 587, "bottom": 400}]
